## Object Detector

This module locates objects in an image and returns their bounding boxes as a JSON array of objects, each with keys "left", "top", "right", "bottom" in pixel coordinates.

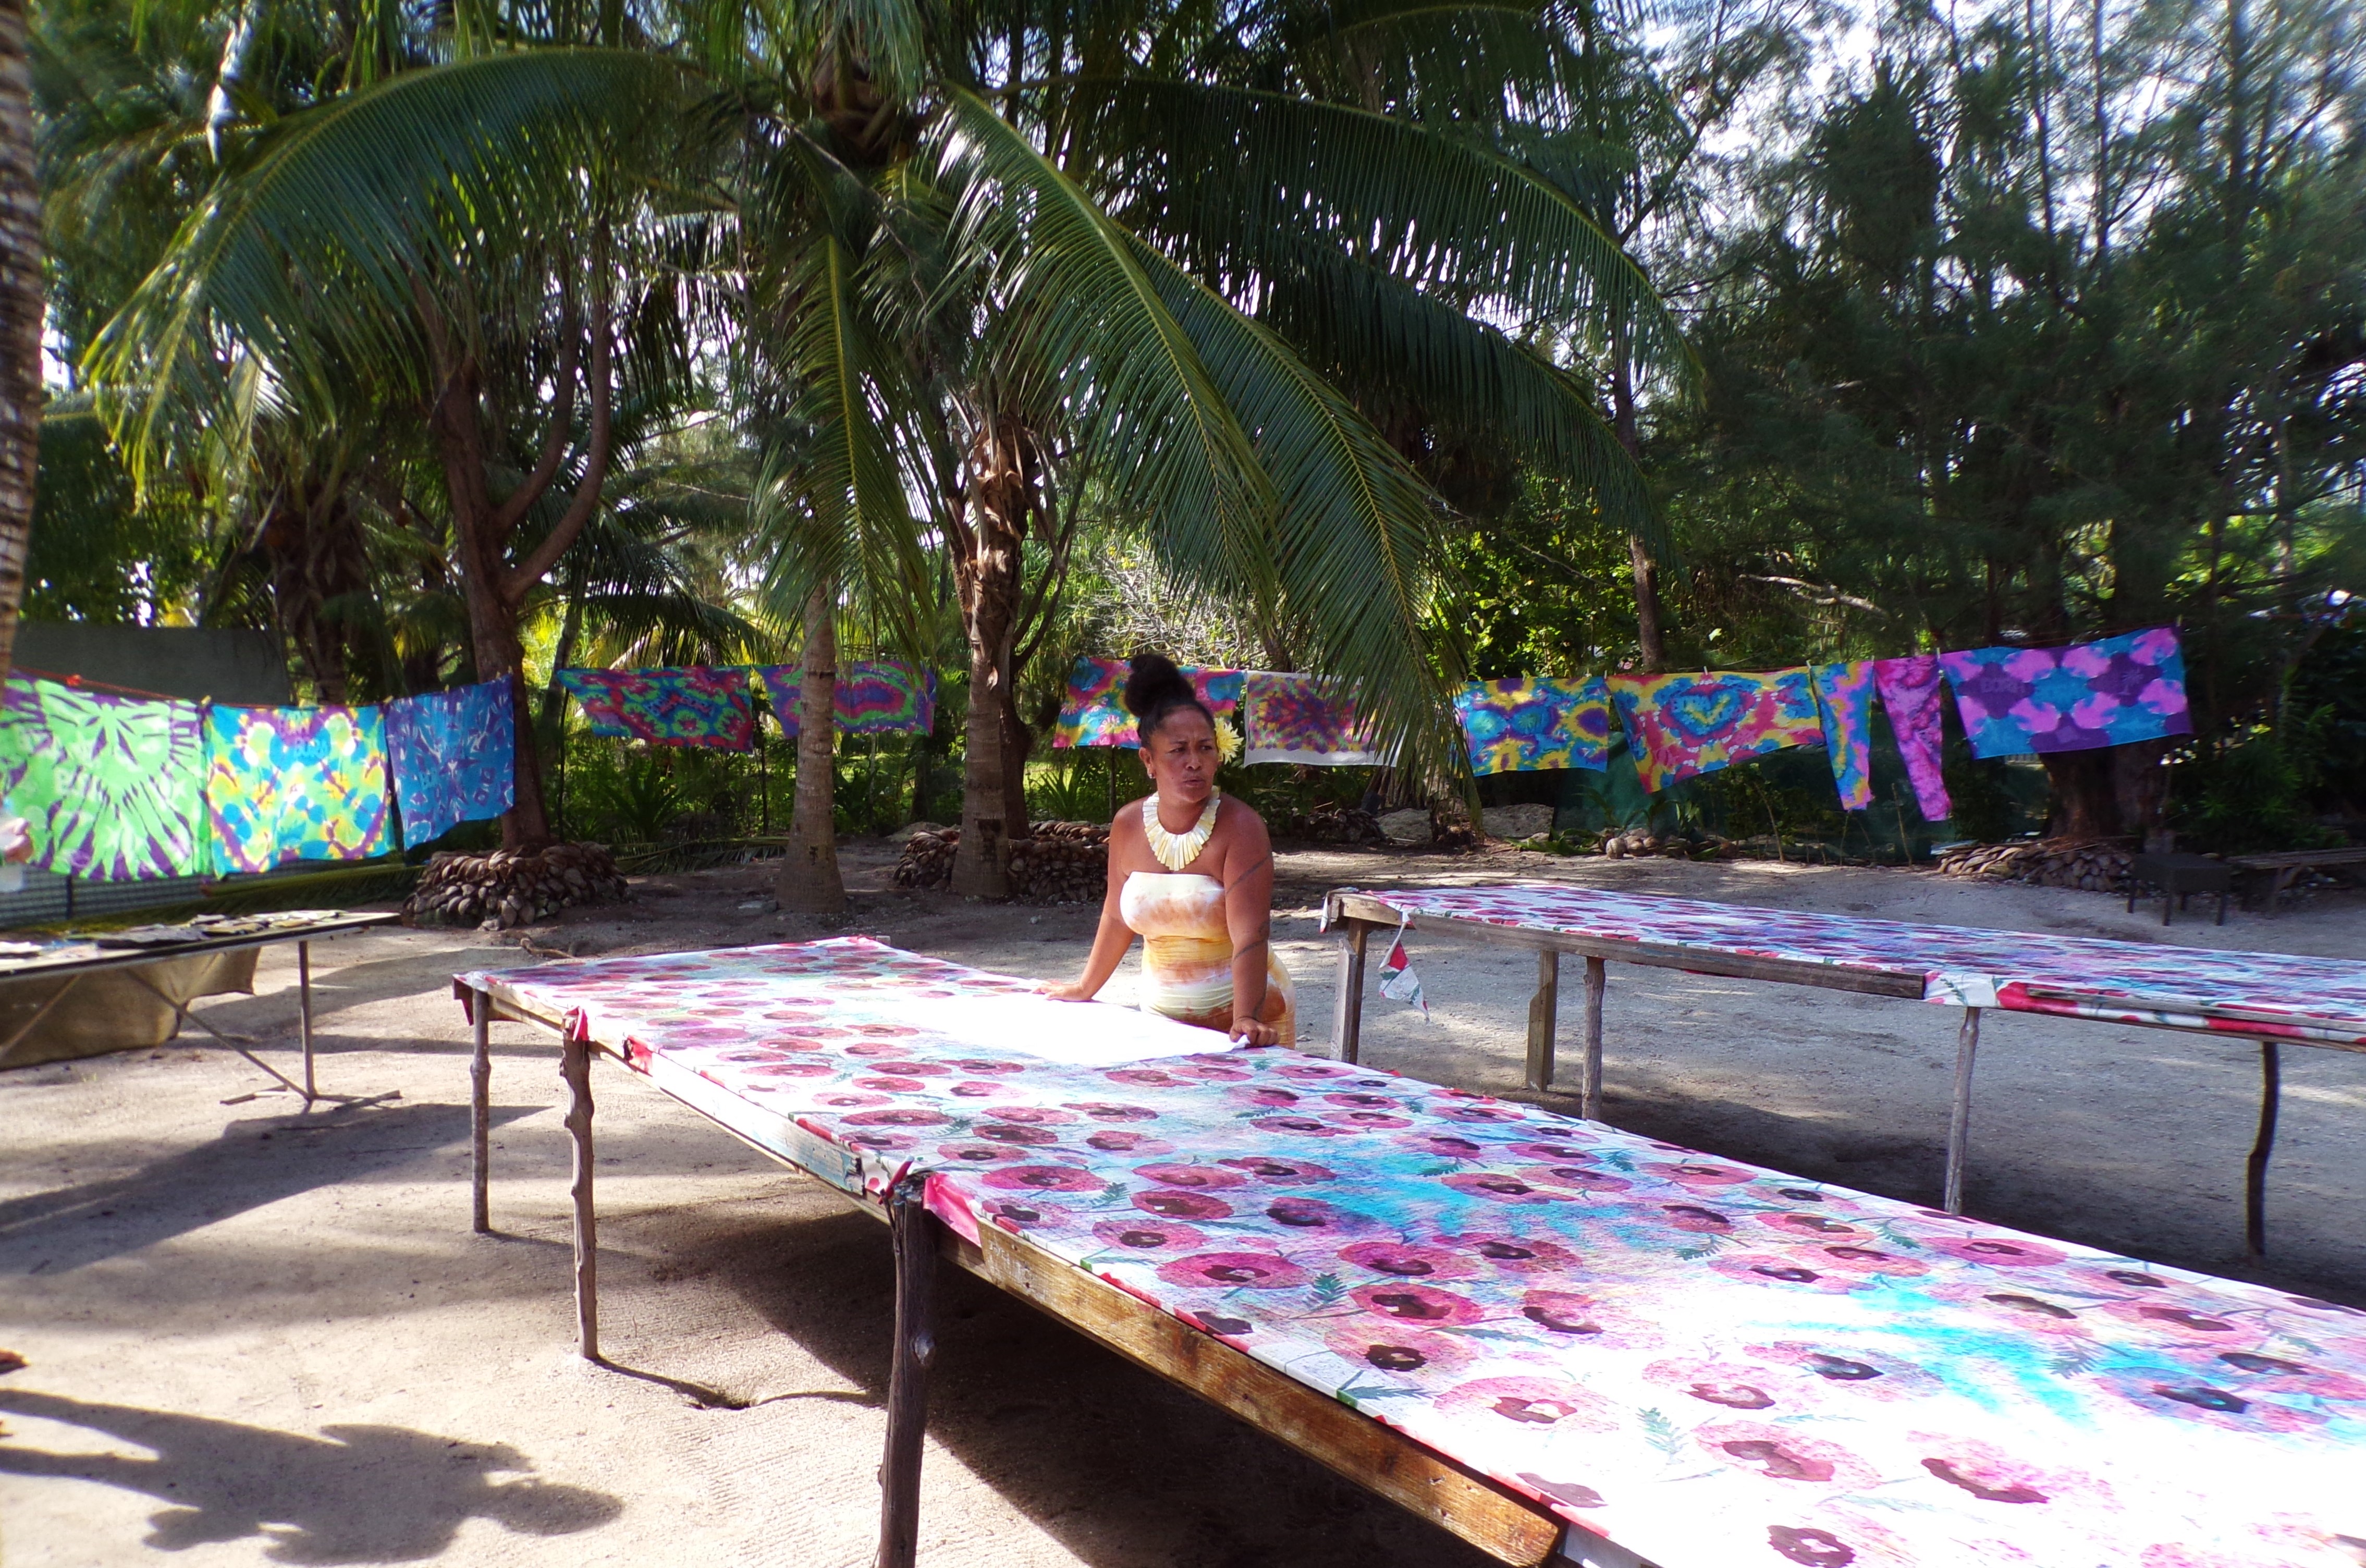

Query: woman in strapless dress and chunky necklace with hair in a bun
[{"left": 1050, "top": 653, "right": 1296, "bottom": 1045}]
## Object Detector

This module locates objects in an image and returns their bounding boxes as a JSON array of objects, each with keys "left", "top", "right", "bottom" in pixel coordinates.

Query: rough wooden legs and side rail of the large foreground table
[{"left": 452, "top": 979, "right": 1609, "bottom": 1568}]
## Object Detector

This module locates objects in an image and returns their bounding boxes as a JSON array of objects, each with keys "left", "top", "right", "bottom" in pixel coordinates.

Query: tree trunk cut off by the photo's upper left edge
[{"left": 0, "top": 0, "right": 43, "bottom": 677}]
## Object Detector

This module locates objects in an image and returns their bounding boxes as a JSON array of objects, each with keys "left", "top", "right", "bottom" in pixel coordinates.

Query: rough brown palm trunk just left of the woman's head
[{"left": 953, "top": 416, "right": 1036, "bottom": 899}]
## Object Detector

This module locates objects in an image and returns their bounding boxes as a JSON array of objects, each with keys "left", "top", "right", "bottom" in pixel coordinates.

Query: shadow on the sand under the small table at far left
[{"left": 0, "top": 1105, "right": 537, "bottom": 1277}]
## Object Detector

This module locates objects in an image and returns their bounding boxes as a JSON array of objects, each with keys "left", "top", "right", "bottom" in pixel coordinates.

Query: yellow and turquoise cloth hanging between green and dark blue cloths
[{"left": 206, "top": 707, "right": 393, "bottom": 873}]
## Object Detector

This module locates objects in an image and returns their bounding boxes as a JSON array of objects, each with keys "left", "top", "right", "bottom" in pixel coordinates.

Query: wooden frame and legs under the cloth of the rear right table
[{"left": 1322, "top": 887, "right": 2337, "bottom": 1258}]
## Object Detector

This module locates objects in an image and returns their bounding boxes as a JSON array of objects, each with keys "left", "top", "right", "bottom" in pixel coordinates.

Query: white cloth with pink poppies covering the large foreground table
[{"left": 469, "top": 939, "right": 2366, "bottom": 1568}]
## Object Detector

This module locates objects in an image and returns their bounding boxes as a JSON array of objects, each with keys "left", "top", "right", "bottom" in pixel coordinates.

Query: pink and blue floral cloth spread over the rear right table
[{"left": 1370, "top": 882, "right": 2366, "bottom": 1045}]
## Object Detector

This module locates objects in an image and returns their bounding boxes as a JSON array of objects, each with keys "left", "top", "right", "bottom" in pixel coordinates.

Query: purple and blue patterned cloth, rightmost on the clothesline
[{"left": 1938, "top": 627, "right": 2193, "bottom": 757}]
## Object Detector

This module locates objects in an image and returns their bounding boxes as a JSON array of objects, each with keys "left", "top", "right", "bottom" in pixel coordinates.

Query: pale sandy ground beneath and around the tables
[{"left": 0, "top": 842, "right": 2366, "bottom": 1568}]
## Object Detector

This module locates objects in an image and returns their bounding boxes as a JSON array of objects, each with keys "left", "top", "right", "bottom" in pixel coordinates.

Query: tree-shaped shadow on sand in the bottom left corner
[{"left": 0, "top": 1388, "right": 624, "bottom": 1563}]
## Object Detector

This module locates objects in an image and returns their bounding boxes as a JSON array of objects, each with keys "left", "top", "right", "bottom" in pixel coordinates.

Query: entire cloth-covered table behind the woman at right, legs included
[{"left": 1322, "top": 882, "right": 2366, "bottom": 1256}]
